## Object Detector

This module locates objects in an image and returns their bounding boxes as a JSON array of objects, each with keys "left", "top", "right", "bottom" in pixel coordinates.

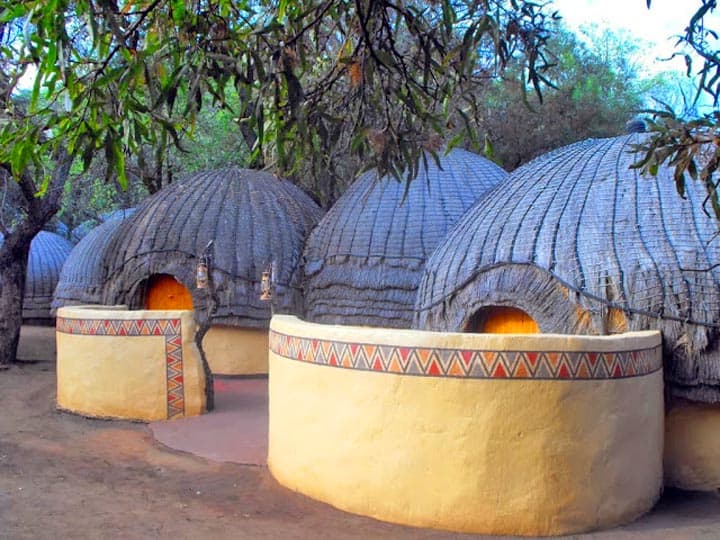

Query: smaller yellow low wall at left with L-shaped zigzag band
[{"left": 56, "top": 306, "right": 207, "bottom": 421}]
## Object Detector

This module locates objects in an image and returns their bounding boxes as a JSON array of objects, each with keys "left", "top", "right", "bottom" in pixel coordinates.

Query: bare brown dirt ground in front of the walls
[{"left": 0, "top": 329, "right": 720, "bottom": 540}]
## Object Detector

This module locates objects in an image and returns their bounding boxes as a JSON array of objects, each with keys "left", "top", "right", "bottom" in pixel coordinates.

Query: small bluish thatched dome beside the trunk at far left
[{"left": 23, "top": 231, "right": 73, "bottom": 320}]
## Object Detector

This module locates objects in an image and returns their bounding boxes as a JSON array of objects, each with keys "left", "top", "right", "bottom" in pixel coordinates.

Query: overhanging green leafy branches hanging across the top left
[{"left": 0, "top": 0, "right": 555, "bottom": 204}]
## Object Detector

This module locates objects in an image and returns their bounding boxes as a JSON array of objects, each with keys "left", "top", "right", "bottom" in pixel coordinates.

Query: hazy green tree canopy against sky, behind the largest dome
[{"left": 475, "top": 24, "right": 673, "bottom": 171}]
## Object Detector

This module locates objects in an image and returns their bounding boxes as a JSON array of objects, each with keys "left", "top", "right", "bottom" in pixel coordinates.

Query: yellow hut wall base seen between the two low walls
[{"left": 203, "top": 325, "right": 268, "bottom": 375}]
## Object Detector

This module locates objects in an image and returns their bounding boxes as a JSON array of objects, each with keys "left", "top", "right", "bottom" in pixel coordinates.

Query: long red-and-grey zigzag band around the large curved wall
[{"left": 270, "top": 330, "right": 662, "bottom": 380}]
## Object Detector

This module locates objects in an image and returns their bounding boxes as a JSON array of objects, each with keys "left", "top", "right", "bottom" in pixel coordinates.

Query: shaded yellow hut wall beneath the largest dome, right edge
[{"left": 665, "top": 400, "right": 720, "bottom": 491}]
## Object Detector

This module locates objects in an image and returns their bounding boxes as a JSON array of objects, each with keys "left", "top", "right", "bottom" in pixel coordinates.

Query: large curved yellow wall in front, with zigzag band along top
[{"left": 268, "top": 316, "right": 663, "bottom": 535}]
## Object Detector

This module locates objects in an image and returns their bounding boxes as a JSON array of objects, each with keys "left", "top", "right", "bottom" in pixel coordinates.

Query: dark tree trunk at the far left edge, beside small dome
[{"left": 0, "top": 234, "right": 34, "bottom": 369}]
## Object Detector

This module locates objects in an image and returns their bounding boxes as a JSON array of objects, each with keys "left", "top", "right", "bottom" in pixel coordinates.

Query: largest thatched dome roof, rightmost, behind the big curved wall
[{"left": 416, "top": 135, "right": 720, "bottom": 401}]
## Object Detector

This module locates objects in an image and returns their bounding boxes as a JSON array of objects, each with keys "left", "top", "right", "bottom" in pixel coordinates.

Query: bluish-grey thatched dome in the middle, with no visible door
[{"left": 305, "top": 149, "right": 507, "bottom": 328}]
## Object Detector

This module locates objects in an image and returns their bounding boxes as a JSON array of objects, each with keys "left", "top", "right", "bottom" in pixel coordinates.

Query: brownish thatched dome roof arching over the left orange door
[{"left": 105, "top": 168, "right": 322, "bottom": 328}]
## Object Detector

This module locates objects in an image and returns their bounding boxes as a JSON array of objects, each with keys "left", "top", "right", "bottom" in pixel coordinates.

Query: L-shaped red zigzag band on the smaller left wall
[{"left": 56, "top": 317, "right": 185, "bottom": 419}]
